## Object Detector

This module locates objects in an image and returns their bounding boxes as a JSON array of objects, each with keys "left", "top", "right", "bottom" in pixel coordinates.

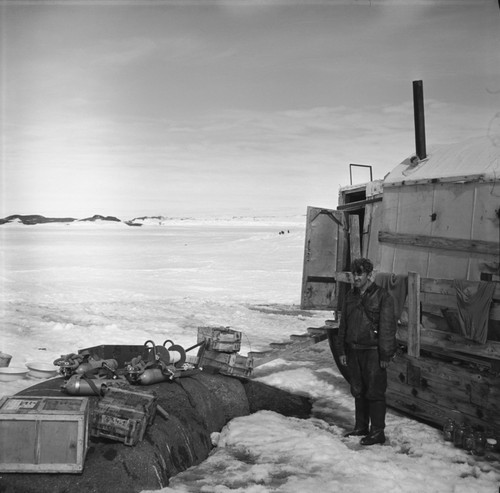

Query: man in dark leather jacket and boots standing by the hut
[{"left": 337, "top": 258, "right": 397, "bottom": 445}]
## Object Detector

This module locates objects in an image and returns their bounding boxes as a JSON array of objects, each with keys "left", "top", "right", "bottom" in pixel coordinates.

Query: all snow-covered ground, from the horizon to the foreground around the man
[{"left": 0, "top": 217, "right": 500, "bottom": 493}]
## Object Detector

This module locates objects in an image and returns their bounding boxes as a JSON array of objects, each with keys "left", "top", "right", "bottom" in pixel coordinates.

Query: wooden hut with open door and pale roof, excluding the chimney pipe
[{"left": 301, "top": 82, "right": 500, "bottom": 437}]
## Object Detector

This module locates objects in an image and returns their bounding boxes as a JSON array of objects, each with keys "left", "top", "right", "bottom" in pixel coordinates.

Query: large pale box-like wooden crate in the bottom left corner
[{"left": 0, "top": 396, "right": 89, "bottom": 473}]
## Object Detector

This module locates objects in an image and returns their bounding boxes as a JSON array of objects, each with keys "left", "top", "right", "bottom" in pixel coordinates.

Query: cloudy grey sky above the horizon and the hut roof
[{"left": 0, "top": 0, "right": 500, "bottom": 219}]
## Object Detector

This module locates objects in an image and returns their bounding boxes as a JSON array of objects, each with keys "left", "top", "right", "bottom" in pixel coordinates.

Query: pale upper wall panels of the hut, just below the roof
[{"left": 378, "top": 182, "right": 500, "bottom": 280}]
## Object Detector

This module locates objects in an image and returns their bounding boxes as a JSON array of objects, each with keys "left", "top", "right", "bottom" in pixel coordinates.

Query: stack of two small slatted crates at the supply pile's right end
[{"left": 198, "top": 327, "right": 253, "bottom": 377}]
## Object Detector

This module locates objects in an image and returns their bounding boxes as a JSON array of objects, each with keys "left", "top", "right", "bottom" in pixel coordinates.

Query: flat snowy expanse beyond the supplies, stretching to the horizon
[{"left": 0, "top": 215, "right": 308, "bottom": 372}]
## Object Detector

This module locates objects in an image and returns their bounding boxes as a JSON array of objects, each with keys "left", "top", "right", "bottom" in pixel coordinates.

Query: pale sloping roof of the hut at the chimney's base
[{"left": 384, "top": 135, "right": 500, "bottom": 186}]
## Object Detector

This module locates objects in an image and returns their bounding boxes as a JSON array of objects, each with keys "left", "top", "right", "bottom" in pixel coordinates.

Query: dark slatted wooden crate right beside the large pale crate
[{"left": 90, "top": 387, "right": 157, "bottom": 446}]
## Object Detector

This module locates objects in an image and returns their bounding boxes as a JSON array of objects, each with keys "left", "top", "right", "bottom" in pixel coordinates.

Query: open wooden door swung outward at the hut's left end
[{"left": 300, "top": 207, "right": 347, "bottom": 310}]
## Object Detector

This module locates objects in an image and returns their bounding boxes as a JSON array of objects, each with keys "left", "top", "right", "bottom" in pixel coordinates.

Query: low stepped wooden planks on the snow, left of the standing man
[{"left": 248, "top": 320, "right": 338, "bottom": 368}]
